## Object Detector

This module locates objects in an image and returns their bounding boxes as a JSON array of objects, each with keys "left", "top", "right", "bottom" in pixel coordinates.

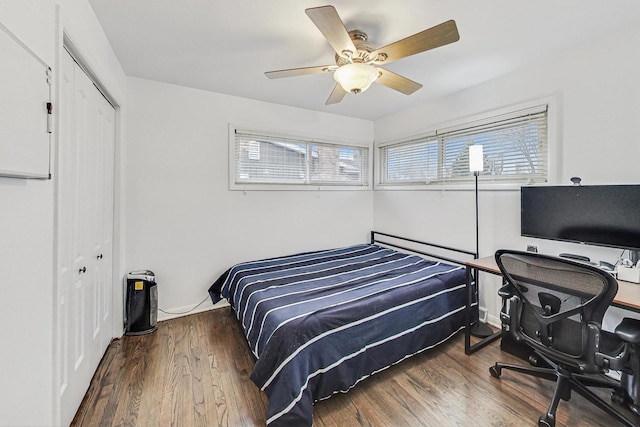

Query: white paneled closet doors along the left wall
[{"left": 54, "top": 52, "right": 115, "bottom": 425}]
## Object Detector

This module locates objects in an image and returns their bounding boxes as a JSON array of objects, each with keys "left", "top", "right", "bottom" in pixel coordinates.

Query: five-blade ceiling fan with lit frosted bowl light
[{"left": 265, "top": 6, "right": 460, "bottom": 105}]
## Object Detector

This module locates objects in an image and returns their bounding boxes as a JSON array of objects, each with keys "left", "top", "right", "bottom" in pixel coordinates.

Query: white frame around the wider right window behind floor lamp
[{"left": 374, "top": 95, "right": 560, "bottom": 191}]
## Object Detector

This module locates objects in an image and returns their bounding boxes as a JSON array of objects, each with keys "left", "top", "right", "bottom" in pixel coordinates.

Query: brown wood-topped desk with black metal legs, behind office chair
[{"left": 464, "top": 256, "right": 640, "bottom": 354}]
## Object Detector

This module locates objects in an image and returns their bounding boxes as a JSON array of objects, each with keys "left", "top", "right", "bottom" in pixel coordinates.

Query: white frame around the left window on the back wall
[{"left": 228, "top": 123, "right": 374, "bottom": 191}]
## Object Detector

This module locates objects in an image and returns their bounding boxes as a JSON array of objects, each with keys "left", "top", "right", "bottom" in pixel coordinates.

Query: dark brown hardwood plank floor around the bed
[{"left": 72, "top": 308, "right": 640, "bottom": 427}]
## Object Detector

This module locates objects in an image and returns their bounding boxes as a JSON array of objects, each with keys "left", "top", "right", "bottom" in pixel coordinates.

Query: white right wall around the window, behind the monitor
[{"left": 374, "top": 22, "right": 640, "bottom": 321}]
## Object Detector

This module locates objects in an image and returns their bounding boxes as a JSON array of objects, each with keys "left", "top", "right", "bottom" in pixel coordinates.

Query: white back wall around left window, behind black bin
[{"left": 126, "top": 78, "right": 373, "bottom": 318}]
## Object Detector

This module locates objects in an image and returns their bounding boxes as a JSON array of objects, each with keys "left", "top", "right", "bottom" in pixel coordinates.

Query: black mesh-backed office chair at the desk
[{"left": 489, "top": 250, "right": 640, "bottom": 426}]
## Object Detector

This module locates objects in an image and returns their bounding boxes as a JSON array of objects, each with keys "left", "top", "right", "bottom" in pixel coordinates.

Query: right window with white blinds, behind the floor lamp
[{"left": 378, "top": 105, "right": 548, "bottom": 186}]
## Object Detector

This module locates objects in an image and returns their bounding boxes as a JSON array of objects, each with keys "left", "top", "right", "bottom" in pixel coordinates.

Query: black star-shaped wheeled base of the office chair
[{"left": 489, "top": 358, "right": 638, "bottom": 427}]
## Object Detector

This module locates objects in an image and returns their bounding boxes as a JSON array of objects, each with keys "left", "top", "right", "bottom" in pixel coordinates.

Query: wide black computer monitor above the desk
[{"left": 520, "top": 185, "right": 640, "bottom": 261}]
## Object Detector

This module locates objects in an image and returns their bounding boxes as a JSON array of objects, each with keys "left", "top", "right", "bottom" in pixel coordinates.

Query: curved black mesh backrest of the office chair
[{"left": 496, "top": 251, "right": 617, "bottom": 358}]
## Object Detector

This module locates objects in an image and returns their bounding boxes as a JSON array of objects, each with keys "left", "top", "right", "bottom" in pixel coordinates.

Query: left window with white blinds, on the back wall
[{"left": 232, "top": 129, "right": 369, "bottom": 188}]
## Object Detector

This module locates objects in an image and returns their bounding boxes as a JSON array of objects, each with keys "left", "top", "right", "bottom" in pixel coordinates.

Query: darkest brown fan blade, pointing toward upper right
[{"left": 369, "top": 20, "right": 460, "bottom": 64}]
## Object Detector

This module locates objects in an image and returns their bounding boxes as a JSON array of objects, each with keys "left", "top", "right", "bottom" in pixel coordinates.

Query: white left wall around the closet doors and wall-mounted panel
[{"left": 0, "top": 0, "right": 125, "bottom": 426}]
